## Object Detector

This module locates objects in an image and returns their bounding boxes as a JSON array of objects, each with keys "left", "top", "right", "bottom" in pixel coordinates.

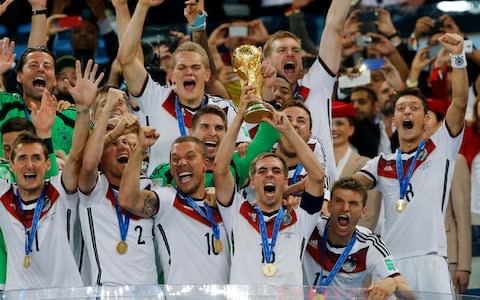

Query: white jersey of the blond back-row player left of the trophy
[{"left": 132, "top": 75, "right": 250, "bottom": 174}]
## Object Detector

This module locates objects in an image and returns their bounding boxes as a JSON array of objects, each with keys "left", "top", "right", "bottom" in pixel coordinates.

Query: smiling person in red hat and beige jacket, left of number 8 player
[{"left": 332, "top": 101, "right": 381, "bottom": 232}]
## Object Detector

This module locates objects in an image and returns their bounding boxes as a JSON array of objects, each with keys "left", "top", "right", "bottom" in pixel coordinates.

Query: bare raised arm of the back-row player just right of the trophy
[{"left": 318, "top": 0, "right": 351, "bottom": 73}]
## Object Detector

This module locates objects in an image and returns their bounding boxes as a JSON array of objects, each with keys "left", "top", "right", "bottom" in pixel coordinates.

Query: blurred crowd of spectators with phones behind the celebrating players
[{"left": 0, "top": 0, "right": 480, "bottom": 292}]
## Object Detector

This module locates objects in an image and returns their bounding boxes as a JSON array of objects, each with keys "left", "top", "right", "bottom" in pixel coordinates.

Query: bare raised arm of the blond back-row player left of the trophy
[{"left": 117, "top": 0, "right": 164, "bottom": 96}]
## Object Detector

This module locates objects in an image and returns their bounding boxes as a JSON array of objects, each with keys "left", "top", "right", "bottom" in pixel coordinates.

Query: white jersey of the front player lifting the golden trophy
[{"left": 219, "top": 193, "right": 322, "bottom": 285}]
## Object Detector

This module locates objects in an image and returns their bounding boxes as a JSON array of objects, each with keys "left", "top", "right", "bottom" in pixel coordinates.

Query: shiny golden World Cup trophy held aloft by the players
[{"left": 233, "top": 45, "right": 272, "bottom": 123}]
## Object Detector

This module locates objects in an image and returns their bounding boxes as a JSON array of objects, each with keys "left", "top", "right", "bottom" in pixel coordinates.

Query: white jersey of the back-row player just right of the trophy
[{"left": 296, "top": 57, "right": 337, "bottom": 188}]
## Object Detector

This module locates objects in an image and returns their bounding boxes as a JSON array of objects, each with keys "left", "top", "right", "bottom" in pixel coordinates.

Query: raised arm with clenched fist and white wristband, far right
[{"left": 438, "top": 33, "right": 468, "bottom": 136}]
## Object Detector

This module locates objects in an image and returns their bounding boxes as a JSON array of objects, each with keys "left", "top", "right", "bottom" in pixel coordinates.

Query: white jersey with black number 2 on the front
[{"left": 79, "top": 174, "right": 158, "bottom": 286}]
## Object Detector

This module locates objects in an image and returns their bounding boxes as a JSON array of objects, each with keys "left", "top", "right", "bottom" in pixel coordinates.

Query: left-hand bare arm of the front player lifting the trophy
[{"left": 213, "top": 85, "right": 261, "bottom": 206}]
